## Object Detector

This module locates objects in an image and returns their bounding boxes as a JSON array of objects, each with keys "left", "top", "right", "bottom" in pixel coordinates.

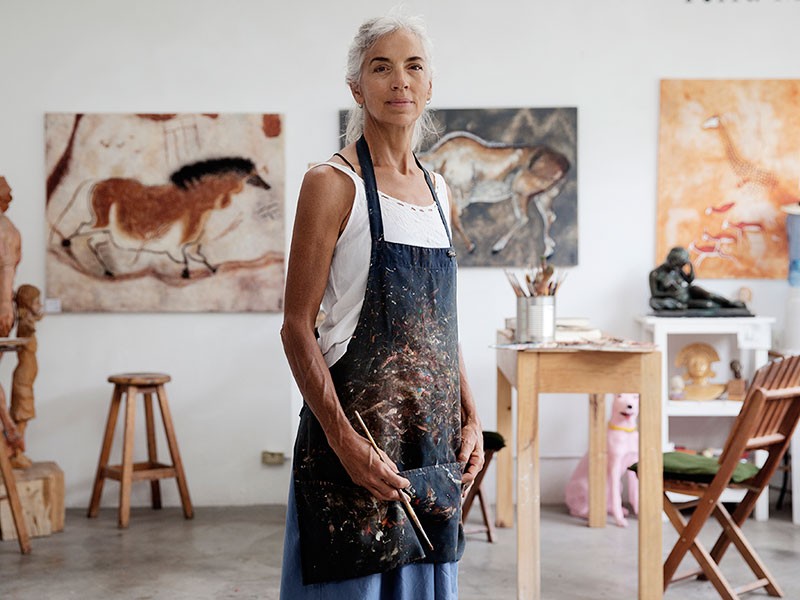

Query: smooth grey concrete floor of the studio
[{"left": 0, "top": 494, "right": 800, "bottom": 600}]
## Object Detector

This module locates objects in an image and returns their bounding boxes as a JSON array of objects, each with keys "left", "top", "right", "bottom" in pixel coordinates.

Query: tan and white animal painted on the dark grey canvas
[{"left": 420, "top": 131, "right": 570, "bottom": 256}]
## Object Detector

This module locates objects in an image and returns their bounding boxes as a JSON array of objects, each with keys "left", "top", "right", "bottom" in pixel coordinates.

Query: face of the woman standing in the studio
[{"left": 352, "top": 30, "right": 432, "bottom": 126}]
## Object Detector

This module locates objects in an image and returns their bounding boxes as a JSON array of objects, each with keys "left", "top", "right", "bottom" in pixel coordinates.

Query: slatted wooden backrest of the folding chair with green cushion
[{"left": 719, "top": 356, "right": 800, "bottom": 487}]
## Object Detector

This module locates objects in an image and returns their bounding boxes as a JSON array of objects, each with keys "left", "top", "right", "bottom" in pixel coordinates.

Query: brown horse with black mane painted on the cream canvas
[{"left": 61, "top": 158, "right": 270, "bottom": 279}]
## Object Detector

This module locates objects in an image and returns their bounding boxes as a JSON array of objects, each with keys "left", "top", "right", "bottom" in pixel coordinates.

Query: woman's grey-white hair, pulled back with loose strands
[{"left": 345, "top": 12, "right": 438, "bottom": 150}]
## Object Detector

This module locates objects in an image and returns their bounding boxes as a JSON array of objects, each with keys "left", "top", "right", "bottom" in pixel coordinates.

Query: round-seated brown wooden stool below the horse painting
[{"left": 87, "top": 373, "right": 194, "bottom": 529}]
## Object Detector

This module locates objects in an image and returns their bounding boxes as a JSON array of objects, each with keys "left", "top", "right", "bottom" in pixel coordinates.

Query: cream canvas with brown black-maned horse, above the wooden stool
[{"left": 45, "top": 113, "right": 285, "bottom": 312}]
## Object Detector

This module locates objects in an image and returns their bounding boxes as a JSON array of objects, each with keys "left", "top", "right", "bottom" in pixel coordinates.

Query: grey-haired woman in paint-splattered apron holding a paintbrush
[{"left": 281, "top": 17, "right": 483, "bottom": 600}]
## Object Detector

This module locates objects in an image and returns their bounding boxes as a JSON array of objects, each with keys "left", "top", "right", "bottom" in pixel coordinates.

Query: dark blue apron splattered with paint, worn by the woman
[{"left": 294, "top": 137, "right": 464, "bottom": 584}]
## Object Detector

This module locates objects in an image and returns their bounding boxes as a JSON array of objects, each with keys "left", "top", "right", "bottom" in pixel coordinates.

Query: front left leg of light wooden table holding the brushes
[{"left": 517, "top": 352, "right": 542, "bottom": 600}]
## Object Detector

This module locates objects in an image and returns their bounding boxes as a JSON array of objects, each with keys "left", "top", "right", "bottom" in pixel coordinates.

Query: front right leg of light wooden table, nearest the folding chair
[{"left": 639, "top": 352, "right": 664, "bottom": 600}]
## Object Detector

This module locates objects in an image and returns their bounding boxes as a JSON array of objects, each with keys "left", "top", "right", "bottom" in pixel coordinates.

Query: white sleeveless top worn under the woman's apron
[{"left": 312, "top": 162, "right": 450, "bottom": 367}]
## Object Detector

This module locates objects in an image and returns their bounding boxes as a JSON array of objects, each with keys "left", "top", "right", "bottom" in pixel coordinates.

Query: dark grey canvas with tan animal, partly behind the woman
[{"left": 340, "top": 108, "right": 578, "bottom": 267}]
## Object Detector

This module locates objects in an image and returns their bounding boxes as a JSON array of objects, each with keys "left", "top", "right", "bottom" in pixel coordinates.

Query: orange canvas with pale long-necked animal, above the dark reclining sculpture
[{"left": 656, "top": 80, "right": 800, "bottom": 279}]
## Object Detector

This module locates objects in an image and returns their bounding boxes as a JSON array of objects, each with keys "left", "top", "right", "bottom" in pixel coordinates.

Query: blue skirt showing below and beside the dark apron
[{"left": 281, "top": 481, "right": 458, "bottom": 600}]
